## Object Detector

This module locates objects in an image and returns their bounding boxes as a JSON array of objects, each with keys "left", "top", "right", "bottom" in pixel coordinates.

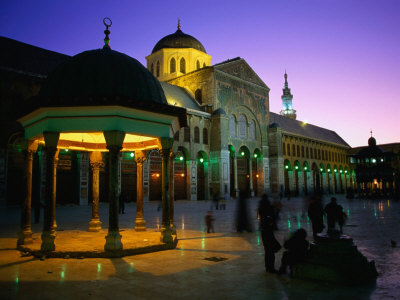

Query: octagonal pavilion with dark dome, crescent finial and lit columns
[{"left": 18, "top": 19, "right": 186, "bottom": 256}]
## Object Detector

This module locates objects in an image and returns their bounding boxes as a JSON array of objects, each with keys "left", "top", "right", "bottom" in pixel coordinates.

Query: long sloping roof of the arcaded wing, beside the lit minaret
[{"left": 269, "top": 112, "right": 350, "bottom": 147}]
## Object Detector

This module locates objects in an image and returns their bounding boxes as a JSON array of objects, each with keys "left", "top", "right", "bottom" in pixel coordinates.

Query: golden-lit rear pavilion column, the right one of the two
[{"left": 135, "top": 151, "right": 146, "bottom": 231}]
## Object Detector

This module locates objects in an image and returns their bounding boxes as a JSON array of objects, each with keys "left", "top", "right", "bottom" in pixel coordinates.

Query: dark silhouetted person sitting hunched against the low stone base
[{"left": 278, "top": 228, "right": 309, "bottom": 274}]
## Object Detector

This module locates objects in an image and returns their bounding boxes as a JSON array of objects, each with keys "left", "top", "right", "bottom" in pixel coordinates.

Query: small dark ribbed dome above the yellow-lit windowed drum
[{"left": 151, "top": 29, "right": 207, "bottom": 53}]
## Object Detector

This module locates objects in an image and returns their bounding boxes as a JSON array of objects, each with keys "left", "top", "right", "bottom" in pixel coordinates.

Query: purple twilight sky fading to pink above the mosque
[{"left": 0, "top": 0, "right": 400, "bottom": 147}]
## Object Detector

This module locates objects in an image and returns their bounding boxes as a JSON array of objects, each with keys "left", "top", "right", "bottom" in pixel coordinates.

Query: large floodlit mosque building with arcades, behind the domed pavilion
[{"left": 0, "top": 19, "right": 355, "bottom": 212}]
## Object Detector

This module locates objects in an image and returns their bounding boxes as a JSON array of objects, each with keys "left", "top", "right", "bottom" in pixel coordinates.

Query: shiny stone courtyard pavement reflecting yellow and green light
[{"left": 0, "top": 197, "right": 400, "bottom": 300}]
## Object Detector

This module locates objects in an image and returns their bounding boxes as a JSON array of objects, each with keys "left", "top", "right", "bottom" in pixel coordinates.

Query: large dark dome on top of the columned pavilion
[{"left": 39, "top": 49, "right": 167, "bottom": 106}]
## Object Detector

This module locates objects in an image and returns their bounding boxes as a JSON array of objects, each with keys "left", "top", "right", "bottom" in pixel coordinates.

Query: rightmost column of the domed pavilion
[{"left": 160, "top": 137, "right": 174, "bottom": 243}]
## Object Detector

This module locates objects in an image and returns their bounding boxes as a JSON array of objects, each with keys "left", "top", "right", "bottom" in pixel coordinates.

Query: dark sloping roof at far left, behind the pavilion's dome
[{"left": 0, "top": 36, "right": 70, "bottom": 77}]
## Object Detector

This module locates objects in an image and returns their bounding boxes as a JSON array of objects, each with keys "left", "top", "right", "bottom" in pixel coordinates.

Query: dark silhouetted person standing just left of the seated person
[{"left": 258, "top": 194, "right": 281, "bottom": 273}]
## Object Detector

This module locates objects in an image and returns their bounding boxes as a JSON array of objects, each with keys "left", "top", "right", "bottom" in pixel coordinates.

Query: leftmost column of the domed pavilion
[{"left": 17, "top": 141, "right": 34, "bottom": 246}]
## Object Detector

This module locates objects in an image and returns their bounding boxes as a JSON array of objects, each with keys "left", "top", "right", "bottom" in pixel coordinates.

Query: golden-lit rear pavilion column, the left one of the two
[{"left": 89, "top": 151, "right": 103, "bottom": 232}]
